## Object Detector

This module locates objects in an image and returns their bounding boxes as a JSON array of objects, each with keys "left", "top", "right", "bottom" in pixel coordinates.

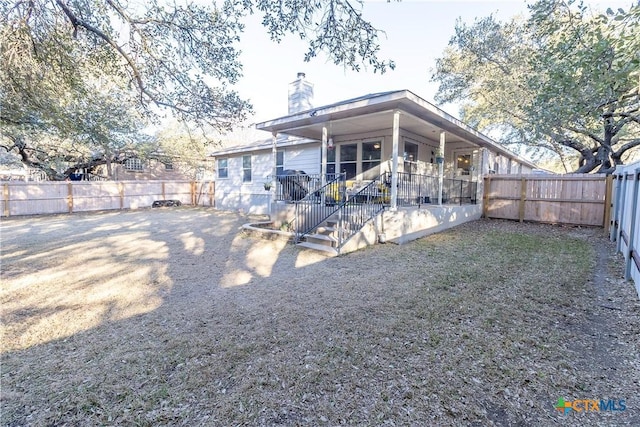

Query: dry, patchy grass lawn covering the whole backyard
[{"left": 1, "top": 208, "right": 640, "bottom": 426}]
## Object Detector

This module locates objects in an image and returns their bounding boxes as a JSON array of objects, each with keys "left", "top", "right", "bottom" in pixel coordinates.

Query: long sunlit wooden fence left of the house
[{"left": 0, "top": 181, "right": 215, "bottom": 217}]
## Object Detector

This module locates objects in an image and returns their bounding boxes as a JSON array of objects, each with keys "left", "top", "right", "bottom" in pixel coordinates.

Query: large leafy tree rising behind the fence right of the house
[{"left": 432, "top": 0, "right": 640, "bottom": 173}]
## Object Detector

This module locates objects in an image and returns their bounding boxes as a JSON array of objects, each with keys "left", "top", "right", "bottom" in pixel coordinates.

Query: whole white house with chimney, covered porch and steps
[{"left": 213, "top": 73, "right": 536, "bottom": 251}]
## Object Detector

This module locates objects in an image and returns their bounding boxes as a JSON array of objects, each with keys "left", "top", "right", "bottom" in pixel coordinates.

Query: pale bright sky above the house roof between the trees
[{"left": 230, "top": 0, "right": 631, "bottom": 125}]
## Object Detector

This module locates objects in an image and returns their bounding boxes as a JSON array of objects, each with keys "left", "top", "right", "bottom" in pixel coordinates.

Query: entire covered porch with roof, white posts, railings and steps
[{"left": 256, "top": 90, "right": 524, "bottom": 252}]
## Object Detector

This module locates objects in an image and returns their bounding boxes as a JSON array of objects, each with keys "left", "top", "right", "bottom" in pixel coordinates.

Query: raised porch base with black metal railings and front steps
[{"left": 272, "top": 173, "right": 482, "bottom": 253}]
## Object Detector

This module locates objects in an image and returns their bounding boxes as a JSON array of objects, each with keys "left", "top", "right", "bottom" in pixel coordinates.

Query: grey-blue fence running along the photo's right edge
[{"left": 610, "top": 162, "right": 640, "bottom": 297}]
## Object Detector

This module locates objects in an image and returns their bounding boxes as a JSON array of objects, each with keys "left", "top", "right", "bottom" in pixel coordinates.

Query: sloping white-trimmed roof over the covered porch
[{"left": 256, "top": 90, "right": 537, "bottom": 168}]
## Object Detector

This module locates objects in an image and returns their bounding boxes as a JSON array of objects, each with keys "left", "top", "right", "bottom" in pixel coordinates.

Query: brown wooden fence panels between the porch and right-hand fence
[{"left": 483, "top": 174, "right": 611, "bottom": 227}]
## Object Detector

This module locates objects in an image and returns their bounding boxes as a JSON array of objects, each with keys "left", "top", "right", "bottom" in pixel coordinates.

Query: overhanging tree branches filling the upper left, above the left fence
[{"left": 0, "top": 0, "right": 394, "bottom": 179}]
